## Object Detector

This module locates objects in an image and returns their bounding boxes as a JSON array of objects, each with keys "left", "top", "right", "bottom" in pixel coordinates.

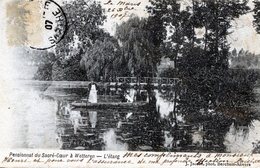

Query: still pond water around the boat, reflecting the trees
[{"left": 3, "top": 83, "right": 260, "bottom": 152}]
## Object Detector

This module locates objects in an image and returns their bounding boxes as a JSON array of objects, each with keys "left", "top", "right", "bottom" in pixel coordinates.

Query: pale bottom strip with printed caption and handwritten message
[{"left": 0, "top": 151, "right": 260, "bottom": 167}]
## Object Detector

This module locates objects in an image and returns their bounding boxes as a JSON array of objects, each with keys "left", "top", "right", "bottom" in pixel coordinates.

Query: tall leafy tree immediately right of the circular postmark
[{"left": 35, "top": 0, "right": 107, "bottom": 80}]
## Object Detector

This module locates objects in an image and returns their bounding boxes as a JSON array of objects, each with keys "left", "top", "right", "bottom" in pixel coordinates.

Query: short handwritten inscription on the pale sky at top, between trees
[{"left": 103, "top": 0, "right": 142, "bottom": 20}]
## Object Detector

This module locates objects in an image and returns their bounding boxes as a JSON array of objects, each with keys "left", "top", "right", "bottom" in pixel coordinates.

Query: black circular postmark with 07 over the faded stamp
[{"left": 29, "top": 0, "right": 67, "bottom": 50}]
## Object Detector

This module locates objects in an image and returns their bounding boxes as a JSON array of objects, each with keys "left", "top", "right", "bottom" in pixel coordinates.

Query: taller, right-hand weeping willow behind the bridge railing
[{"left": 116, "top": 17, "right": 160, "bottom": 76}]
